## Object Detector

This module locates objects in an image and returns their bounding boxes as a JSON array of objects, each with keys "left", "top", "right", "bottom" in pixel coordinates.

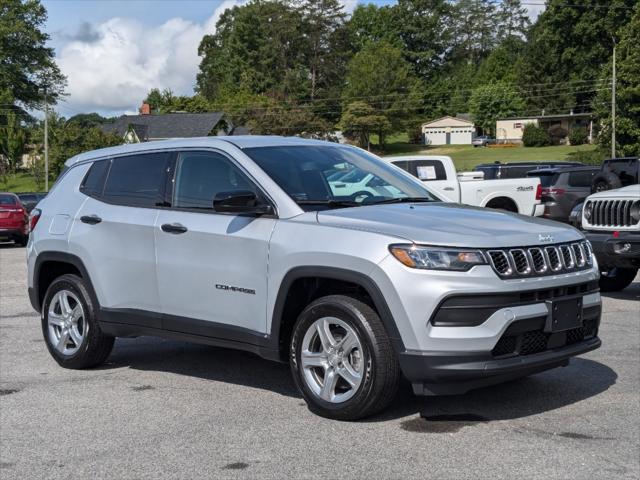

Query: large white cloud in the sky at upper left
[{"left": 57, "top": 0, "right": 243, "bottom": 115}]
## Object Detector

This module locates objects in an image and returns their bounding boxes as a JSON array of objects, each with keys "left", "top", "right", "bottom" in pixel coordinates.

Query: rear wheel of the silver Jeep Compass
[{"left": 42, "top": 275, "right": 115, "bottom": 369}]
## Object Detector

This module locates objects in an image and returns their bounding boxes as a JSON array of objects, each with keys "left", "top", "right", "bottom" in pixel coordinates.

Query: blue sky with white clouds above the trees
[{"left": 42, "top": 0, "right": 539, "bottom": 117}]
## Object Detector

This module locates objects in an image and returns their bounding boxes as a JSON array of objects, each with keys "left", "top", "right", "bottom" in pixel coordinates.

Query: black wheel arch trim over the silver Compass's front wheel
[{"left": 269, "top": 266, "right": 405, "bottom": 353}]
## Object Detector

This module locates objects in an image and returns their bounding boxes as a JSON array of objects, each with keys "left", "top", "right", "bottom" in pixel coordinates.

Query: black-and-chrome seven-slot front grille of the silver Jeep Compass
[{"left": 487, "top": 241, "right": 593, "bottom": 278}]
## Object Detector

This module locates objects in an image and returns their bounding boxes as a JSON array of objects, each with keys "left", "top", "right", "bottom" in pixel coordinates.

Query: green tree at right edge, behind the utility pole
[{"left": 593, "top": 3, "right": 640, "bottom": 156}]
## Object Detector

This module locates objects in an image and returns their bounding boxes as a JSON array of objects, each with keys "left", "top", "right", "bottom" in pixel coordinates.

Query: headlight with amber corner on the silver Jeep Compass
[{"left": 389, "top": 245, "right": 487, "bottom": 272}]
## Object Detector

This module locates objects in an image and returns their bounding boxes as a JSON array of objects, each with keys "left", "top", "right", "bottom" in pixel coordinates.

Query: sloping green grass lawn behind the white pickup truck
[{"left": 383, "top": 142, "right": 596, "bottom": 171}]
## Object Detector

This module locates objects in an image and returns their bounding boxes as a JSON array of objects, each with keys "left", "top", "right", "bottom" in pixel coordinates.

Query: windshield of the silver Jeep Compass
[{"left": 244, "top": 145, "right": 440, "bottom": 210}]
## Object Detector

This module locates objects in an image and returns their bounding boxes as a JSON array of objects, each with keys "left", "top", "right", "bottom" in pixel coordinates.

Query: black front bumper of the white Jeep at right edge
[{"left": 584, "top": 231, "right": 640, "bottom": 268}]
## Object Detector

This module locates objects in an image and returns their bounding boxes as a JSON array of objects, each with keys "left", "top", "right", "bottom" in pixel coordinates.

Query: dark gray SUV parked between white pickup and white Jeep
[{"left": 527, "top": 167, "right": 600, "bottom": 223}]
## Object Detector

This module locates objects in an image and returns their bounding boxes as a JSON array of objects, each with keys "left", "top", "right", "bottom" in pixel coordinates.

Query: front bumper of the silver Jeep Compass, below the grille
[{"left": 399, "top": 282, "right": 601, "bottom": 395}]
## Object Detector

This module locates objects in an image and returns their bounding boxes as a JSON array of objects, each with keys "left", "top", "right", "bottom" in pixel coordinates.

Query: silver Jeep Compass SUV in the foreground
[{"left": 28, "top": 137, "right": 600, "bottom": 419}]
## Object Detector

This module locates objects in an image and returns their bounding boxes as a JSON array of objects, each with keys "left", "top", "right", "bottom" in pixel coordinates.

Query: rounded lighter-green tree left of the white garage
[{"left": 343, "top": 42, "right": 422, "bottom": 145}]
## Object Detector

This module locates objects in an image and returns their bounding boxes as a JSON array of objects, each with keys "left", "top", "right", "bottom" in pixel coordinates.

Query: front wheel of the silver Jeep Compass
[{"left": 289, "top": 295, "right": 400, "bottom": 420}]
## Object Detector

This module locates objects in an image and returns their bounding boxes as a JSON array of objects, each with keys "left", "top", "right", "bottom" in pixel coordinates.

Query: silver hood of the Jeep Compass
[{"left": 318, "top": 202, "right": 584, "bottom": 248}]
